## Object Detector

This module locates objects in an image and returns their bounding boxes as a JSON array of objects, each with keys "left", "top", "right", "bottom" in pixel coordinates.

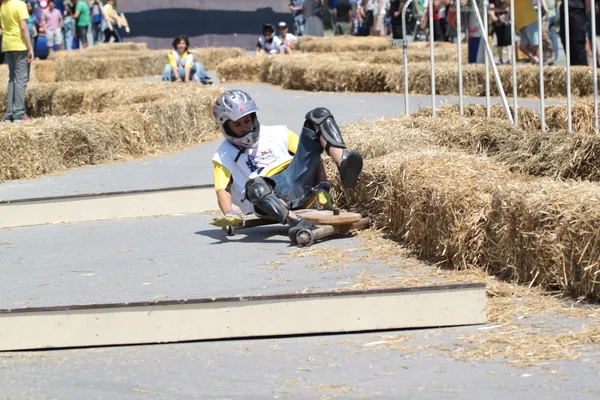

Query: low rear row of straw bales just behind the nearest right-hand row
[{"left": 343, "top": 116, "right": 600, "bottom": 181}]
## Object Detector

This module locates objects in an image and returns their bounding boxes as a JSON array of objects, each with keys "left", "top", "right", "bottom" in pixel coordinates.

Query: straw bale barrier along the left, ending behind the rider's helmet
[{"left": 0, "top": 83, "right": 221, "bottom": 181}]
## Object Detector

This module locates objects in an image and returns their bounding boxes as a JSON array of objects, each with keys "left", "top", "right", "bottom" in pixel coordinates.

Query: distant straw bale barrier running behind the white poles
[{"left": 217, "top": 37, "right": 593, "bottom": 98}]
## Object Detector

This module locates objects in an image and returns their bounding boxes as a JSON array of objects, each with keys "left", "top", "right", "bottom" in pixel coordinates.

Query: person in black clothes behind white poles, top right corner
[{"left": 556, "top": 0, "right": 588, "bottom": 65}]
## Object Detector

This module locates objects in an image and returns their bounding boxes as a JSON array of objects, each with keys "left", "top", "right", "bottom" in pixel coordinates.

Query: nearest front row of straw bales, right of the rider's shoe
[{"left": 329, "top": 142, "right": 600, "bottom": 300}]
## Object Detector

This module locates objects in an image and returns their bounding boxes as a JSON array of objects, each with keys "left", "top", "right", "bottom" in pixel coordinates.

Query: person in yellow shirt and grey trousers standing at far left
[{"left": 0, "top": 0, "right": 33, "bottom": 122}]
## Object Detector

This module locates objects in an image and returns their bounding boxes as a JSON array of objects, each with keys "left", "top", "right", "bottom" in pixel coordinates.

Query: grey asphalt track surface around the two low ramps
[{"left": 0, "top": 79, "right": 600, "bottom": 399}]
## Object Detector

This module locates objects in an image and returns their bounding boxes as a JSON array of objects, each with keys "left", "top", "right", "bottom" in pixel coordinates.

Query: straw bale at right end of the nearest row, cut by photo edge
[{"left": 484, "top": 180, "right": 600, "bottom": 300}]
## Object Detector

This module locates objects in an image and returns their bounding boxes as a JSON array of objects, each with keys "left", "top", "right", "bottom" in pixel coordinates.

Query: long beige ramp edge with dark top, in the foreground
[{"left": 0, "top": 283, "right": 487, "bottom": 351}]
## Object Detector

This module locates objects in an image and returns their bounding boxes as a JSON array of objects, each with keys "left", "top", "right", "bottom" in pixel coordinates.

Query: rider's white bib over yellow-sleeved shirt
[{"left": 212, "top": 125, "right": 299, "bottom": 213}]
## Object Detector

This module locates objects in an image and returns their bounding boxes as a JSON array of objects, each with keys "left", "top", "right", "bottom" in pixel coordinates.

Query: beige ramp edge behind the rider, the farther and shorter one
[{"left": 0, "top": 185, "right": 218, "bottom": 228}]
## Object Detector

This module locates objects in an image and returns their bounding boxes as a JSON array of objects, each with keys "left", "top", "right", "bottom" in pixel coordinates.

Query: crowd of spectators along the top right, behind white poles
[{"left": 289, "top": 0, "right": 600, "bottom": 65}]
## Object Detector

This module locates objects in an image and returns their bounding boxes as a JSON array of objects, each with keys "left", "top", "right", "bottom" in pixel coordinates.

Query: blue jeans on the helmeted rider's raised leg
[{"left": 271, "top": 128, "right": 323, "bottom": 210}]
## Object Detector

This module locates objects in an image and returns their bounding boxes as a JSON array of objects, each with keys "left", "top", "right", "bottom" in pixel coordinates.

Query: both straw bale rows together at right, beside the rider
[{"left": 330, "top": 116, "right": 600, "bottom": 300}]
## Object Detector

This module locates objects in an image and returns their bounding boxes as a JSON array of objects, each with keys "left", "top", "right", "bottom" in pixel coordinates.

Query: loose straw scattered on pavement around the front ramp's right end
[{"left": 288, "top": 230, "right": 600, "bottom": 368}]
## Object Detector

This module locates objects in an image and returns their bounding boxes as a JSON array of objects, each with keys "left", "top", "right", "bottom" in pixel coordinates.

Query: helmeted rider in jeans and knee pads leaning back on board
[{"left": 212, "top": 90, "right": 363, "bottom": 244}]
